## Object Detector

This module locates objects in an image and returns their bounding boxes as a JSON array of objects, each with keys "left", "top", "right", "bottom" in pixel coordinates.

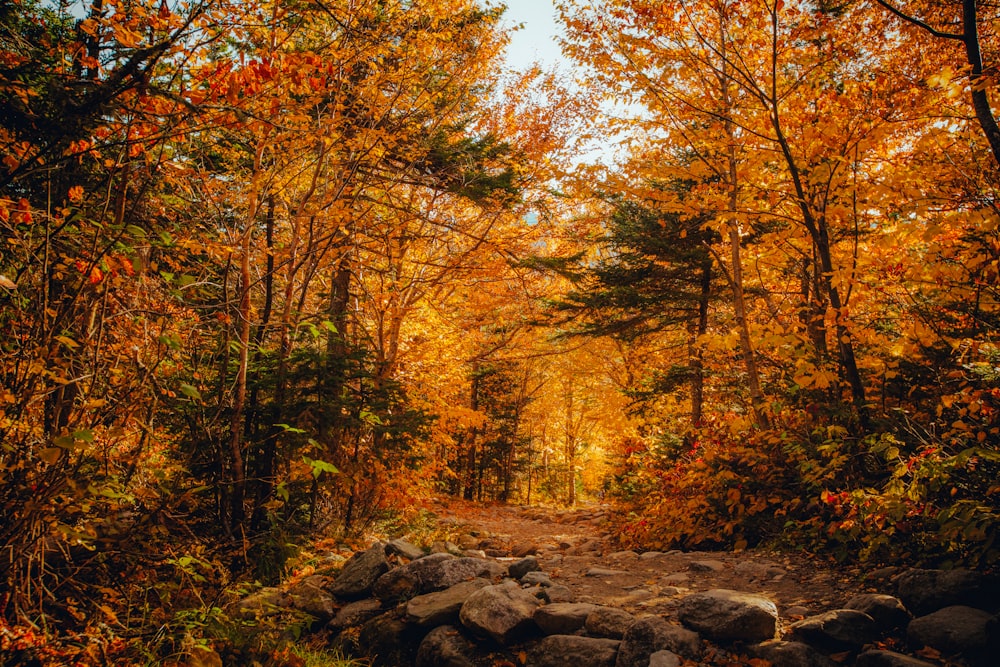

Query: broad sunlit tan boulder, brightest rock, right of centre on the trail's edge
[{"left": 677, "top": 588, "right": 778, "bottom": 642}]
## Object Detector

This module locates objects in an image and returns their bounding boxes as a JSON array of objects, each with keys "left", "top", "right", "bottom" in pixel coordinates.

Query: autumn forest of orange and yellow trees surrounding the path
[{"left": 0, "top": 0, "right": 1000, "bottom": 665}]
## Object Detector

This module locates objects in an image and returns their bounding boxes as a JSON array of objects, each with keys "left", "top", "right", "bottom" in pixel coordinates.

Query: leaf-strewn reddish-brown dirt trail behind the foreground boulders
[{"left": 426, "top": 501, "right": 890, "bottom": 622}]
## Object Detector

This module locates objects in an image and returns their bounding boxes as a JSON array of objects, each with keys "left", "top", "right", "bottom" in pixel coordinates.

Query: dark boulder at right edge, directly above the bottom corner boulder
[{"left": 896, "top": 569, "right": 1000, "bottom": 616}]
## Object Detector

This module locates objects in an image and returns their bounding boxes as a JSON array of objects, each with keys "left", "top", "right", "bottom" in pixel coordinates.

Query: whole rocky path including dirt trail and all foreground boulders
[{"left": 237, "top": 502, "right": 1000, "bottom": 667}]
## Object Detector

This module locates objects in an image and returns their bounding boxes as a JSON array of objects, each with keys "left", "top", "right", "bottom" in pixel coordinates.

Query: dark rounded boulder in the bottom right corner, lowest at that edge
[{"left": 906, "top": 605, "right": 1000, "bottom": 664}]
